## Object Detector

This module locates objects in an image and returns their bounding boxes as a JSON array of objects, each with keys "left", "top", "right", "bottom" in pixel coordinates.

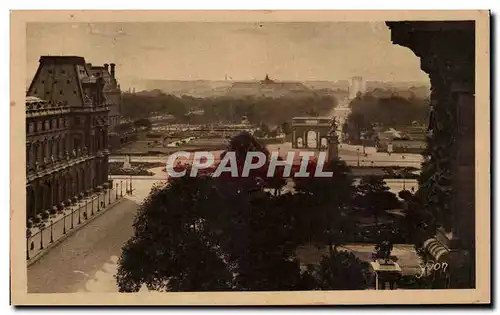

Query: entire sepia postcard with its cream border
[{"left": 10, "top": 11, "right": 491, "bottom": 305}]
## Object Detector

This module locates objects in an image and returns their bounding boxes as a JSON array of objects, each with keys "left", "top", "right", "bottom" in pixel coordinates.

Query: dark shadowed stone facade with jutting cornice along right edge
[{"left": 387, "top": 21, "right": 475, "bottom": 288}]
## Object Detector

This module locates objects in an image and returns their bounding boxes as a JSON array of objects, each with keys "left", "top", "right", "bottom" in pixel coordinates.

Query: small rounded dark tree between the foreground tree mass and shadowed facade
[{"left": 356, "top": 176, "right": 399, "bottom": 226}]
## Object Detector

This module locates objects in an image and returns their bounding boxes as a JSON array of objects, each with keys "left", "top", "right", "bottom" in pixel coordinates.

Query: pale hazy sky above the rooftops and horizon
[{"left": 26, "top": 22, "right": 429, "bottom": 89}]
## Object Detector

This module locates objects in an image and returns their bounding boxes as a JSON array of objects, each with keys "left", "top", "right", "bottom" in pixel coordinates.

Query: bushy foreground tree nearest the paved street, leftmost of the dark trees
[{"left": 117, "top": 177, "right": 232, "bottom": 292}]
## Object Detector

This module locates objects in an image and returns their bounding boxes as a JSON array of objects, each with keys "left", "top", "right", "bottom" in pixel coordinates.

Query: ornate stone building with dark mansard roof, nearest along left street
[{"left": 26, "top": 56, "right": 109, "bottom": 222}]
